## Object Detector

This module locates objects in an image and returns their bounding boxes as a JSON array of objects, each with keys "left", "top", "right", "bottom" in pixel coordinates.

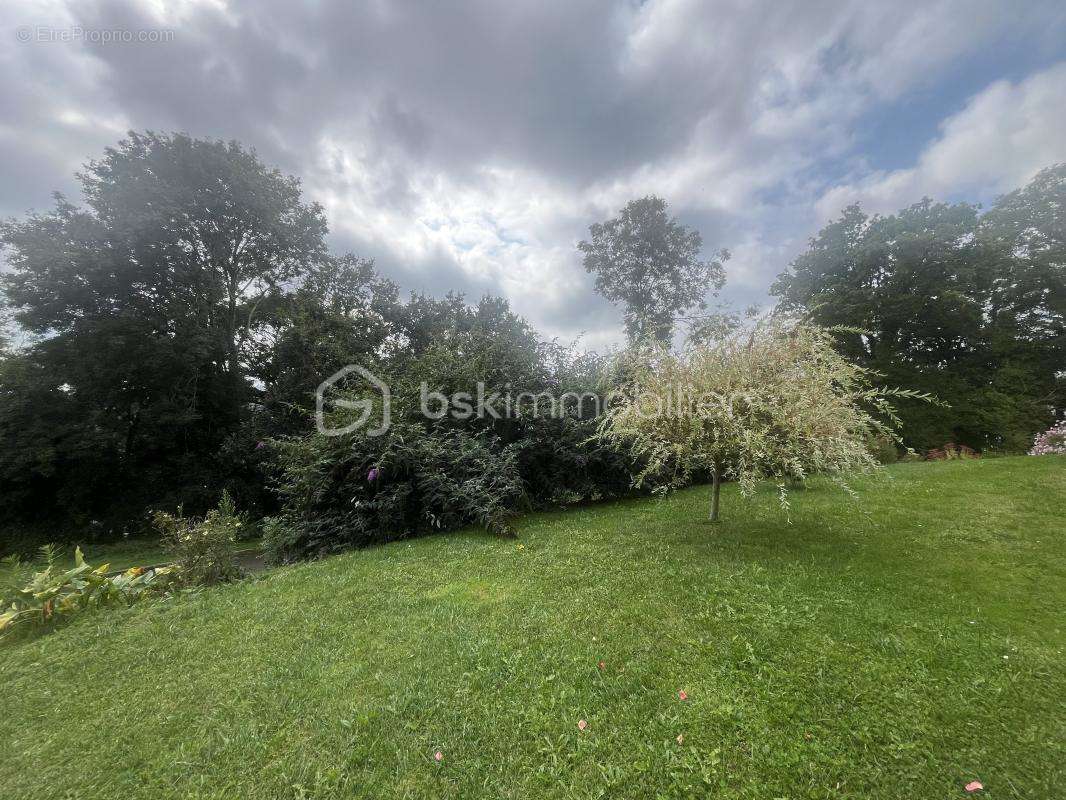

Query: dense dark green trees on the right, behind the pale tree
[{"left": 774, "top": 164, "right": 1066, "bottom": 452}]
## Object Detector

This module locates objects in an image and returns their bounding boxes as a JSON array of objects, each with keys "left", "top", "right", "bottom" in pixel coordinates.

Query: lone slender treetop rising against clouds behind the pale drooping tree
[{"left": 578, "top": 195, "right": 729, "bottom": 343}]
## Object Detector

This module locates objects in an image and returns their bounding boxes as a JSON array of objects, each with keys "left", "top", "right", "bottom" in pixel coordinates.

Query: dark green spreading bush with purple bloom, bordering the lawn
[{"left": 263, "top": 419, "right": 523, "bottom": 562}]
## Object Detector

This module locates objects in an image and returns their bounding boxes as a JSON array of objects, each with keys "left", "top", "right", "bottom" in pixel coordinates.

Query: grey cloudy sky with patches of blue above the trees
[{"left": 0, "top": 0, "right": 1066, "bottom": 347}]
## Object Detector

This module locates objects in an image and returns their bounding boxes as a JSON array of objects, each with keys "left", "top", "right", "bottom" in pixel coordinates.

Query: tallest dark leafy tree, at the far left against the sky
[{"left": 0, "top": 132, "right": 327, "bottom": 529}]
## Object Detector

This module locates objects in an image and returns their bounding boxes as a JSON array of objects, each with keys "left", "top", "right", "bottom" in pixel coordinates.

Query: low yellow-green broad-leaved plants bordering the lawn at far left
[{"left": 0, "top": 545, "right": 180, "bottom": 638}]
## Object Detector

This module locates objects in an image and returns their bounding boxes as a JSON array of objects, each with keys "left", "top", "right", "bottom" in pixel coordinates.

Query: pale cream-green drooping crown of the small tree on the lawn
[{"left": 598, "top": 318, "right": 932, "bottom": 522}]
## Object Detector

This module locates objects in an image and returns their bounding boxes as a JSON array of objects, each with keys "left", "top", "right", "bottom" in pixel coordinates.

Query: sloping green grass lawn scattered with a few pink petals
[{"left": 0, "top": 457, "right": 1066, "bottom": 800}]
